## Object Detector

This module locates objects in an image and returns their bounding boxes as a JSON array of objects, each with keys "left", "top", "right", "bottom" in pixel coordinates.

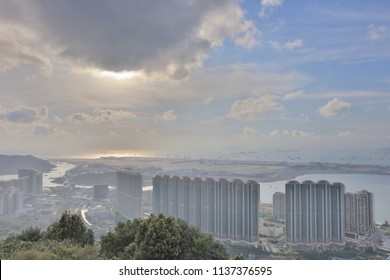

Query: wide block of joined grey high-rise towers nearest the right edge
[{"left": 286, "top": 180, "right": 345, "bottom": 245}]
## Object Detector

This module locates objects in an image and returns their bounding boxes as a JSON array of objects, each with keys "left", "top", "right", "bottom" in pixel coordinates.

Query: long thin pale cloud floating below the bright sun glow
[{"left": 67, "top": 108, "right": 136, "bottom": 124}]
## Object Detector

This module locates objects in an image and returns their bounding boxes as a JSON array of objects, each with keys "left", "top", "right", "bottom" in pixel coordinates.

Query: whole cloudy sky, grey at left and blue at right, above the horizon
[{"left": 0, "top": 0, "right": 390, "bottom": 160}]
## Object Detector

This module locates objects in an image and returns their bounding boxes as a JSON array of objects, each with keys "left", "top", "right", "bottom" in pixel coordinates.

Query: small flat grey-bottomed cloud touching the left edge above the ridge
[{"left": 0, "top": 106, "right": 48, "bottom": 124}]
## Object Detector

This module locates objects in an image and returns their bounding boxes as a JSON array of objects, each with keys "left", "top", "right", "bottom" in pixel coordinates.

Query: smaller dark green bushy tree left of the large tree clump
[{"left": 45, "top": 211, "right": 95, "bottom": 246}]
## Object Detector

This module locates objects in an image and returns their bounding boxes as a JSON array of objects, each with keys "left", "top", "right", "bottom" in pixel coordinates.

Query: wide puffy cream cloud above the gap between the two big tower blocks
[{"left": 228, "top": 95, "right": 283, "bottom": 120}]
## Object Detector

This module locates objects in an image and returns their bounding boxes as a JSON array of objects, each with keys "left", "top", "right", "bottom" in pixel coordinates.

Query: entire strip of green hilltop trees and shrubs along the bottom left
[{"left": 0, "top": 211, "right": 229, "bottom": 260}]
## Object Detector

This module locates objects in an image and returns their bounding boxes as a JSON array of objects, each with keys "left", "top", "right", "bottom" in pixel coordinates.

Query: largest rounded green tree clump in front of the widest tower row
[{"left": 100, "top": 214, "right": 229, "bottom": 260}]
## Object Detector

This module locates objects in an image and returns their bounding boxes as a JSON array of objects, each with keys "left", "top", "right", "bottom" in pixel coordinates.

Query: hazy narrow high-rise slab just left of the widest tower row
[{"left": 116, "top": 169, "right": 143, "bottom": 220}]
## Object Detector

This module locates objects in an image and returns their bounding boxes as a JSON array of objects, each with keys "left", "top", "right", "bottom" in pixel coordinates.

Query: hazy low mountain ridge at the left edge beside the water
[{"left": 0, "top": 155, "right": 56, "bottom": 175}]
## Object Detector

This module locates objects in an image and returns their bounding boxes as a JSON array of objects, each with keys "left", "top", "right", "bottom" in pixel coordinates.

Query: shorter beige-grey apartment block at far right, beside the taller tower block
[{"left": 345, "top": 190, "right": 375, "bottom": 234}]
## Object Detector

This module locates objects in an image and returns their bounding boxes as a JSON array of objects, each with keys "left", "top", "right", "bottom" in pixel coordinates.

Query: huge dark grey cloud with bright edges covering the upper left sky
[{"left": 0, "top": 0, "right": 258, "bottom": 79}]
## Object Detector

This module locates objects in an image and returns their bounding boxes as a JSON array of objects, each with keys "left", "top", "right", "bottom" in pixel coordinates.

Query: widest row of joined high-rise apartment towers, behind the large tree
[{"left": 153, "top": 175, "right": 260, "bottom": 242}]
